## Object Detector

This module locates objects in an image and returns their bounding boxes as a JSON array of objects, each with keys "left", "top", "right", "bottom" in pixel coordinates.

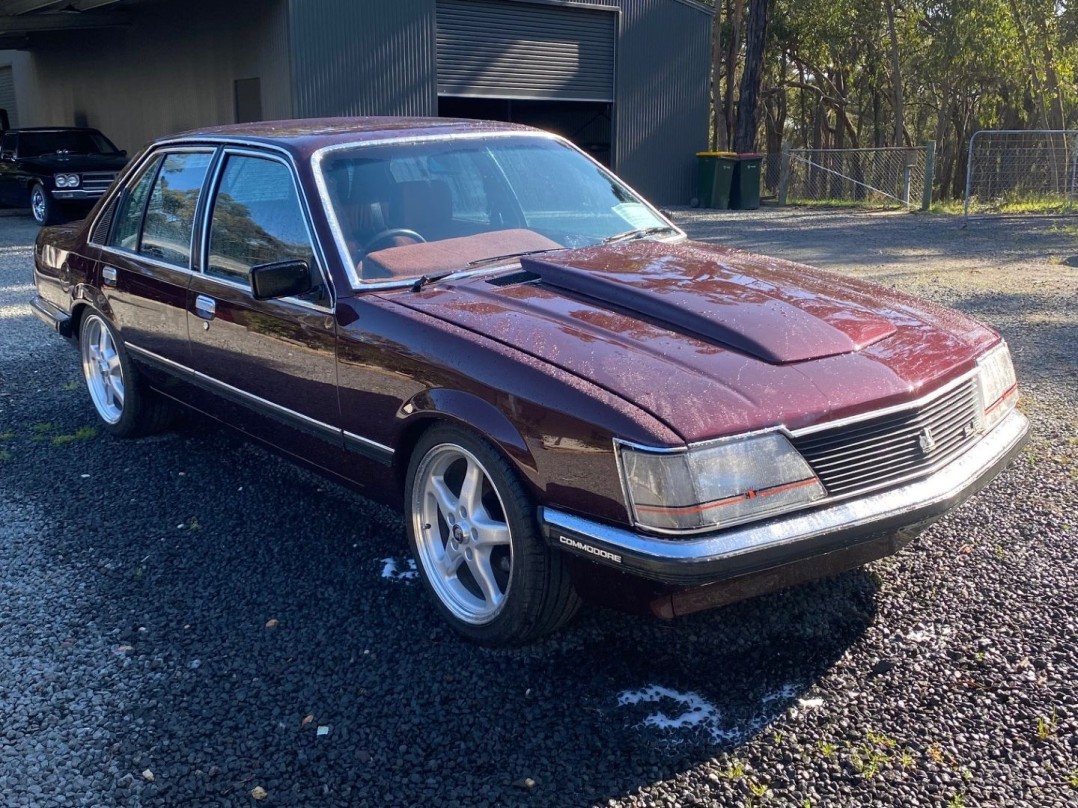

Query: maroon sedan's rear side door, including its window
[{"left": 101, "top": 149, "right": 213, "bottom": 365}]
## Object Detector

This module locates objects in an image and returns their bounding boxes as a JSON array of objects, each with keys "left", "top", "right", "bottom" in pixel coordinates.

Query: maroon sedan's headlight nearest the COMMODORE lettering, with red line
[{"left": 618, "top": 432, "right": 827, "bottom": 532}]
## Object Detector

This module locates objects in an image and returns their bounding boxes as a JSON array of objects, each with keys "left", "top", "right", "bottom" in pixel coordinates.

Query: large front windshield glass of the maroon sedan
[{"left": 320, "top": 135, "right": 679, "bottom": 282}]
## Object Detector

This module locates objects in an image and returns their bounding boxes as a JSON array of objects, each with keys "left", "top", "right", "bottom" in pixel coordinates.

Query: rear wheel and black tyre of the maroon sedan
[{"left": 79, "top": 311, "right": 172, "bottom": 437}]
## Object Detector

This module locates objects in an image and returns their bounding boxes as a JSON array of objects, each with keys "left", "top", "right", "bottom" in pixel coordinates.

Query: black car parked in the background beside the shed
[{"left": 0, "top": 127, "right": 127, "bottom": 224}]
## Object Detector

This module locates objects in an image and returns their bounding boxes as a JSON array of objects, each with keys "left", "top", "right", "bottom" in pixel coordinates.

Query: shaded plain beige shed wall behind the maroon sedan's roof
[{"left": 6, "top": 0, "right": 292, "bottom": 151}]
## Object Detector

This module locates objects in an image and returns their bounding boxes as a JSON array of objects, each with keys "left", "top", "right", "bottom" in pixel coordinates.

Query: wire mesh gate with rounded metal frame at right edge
[{"left": 964, "top": 129, "right": 1078, "bottom": 217}]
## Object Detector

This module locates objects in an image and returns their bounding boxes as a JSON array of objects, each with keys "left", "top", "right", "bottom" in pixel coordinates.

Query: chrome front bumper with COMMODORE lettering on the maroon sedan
[{"left": 539, "top": 410, "right": 1028, "bottom": 586}]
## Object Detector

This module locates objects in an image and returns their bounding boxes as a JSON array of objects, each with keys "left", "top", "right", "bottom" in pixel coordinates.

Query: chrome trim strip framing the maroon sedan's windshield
[{"left": 310, "top": 129, "right": 688, "bottom": 291}]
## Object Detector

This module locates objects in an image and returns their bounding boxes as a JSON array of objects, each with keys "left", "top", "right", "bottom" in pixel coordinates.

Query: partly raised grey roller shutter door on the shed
[{"left": 438, "top": 0, "right": 618, "bottom": 101}]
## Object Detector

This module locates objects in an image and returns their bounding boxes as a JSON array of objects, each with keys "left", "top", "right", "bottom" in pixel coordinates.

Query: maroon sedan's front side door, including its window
[{"left": 186, "top": 149, "right": 343, "bottom": 459}]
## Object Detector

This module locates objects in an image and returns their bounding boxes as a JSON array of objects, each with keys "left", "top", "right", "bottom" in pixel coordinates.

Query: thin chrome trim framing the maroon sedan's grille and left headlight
[{"left": 613, "top": 367, "right": 998, "bottom": 535}]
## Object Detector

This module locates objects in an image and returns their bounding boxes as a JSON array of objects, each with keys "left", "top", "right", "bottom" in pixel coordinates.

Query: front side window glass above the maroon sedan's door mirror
[{"left": 206, "top": 155, "right": 319, "bottom": 288}]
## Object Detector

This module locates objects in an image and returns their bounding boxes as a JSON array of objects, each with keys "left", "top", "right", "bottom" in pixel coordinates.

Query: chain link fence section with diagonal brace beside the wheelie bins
[{"left": 777, "top": 142, "right": 935, "bottom": 208}]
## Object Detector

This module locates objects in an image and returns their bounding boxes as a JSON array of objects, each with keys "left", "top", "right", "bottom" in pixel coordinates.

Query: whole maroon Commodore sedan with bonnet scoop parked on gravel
[{"left": 32, "top": 119, "right": 1027, "bottom": 644}]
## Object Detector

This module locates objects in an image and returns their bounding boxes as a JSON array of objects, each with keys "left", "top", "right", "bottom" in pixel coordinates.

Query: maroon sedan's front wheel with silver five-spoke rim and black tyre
[{"left": 405, "top": 426, "right": 580, "bottom": 646}]
